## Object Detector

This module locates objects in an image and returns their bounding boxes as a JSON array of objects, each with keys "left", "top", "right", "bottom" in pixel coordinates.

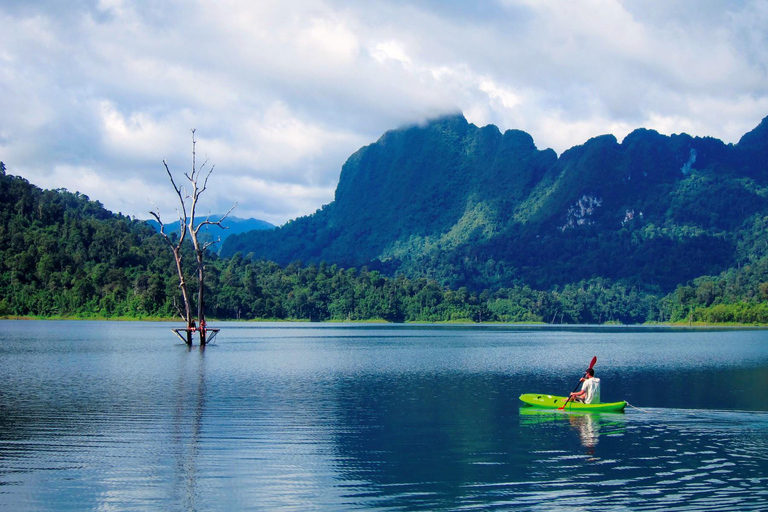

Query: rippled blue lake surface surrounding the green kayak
[{"left": 0, "top": 320, "right": 768, "bottom": 511}]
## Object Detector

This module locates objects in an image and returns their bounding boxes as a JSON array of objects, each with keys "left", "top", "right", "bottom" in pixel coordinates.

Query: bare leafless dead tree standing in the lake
[{"left": 150, "top": 129, "right": 237, "bottom": 346}]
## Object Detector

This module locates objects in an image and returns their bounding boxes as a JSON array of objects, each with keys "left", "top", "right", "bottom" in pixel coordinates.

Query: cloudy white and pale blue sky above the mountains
[{"left": 0, "top": 0, "right": 768, "bottom": 225}]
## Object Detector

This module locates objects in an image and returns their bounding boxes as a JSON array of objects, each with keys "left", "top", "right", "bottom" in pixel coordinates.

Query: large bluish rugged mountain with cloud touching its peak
[{"left": 221, "top": 115, "right": 768, "bottom": 292}]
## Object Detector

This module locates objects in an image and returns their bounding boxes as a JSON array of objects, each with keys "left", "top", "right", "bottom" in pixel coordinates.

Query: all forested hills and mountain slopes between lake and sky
[{"left": 0, "top": 106, "right": 768, "bottom": 324}]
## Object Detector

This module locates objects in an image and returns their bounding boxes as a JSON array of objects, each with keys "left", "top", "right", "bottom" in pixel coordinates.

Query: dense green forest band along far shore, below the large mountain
[{"left": 0, "top": 163, "right": 768, "bottom": 323}]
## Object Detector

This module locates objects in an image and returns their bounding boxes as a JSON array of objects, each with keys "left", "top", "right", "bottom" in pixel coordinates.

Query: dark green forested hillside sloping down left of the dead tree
[{"left": 0, "top": 163, "right": 178, "bottom": 316}]
